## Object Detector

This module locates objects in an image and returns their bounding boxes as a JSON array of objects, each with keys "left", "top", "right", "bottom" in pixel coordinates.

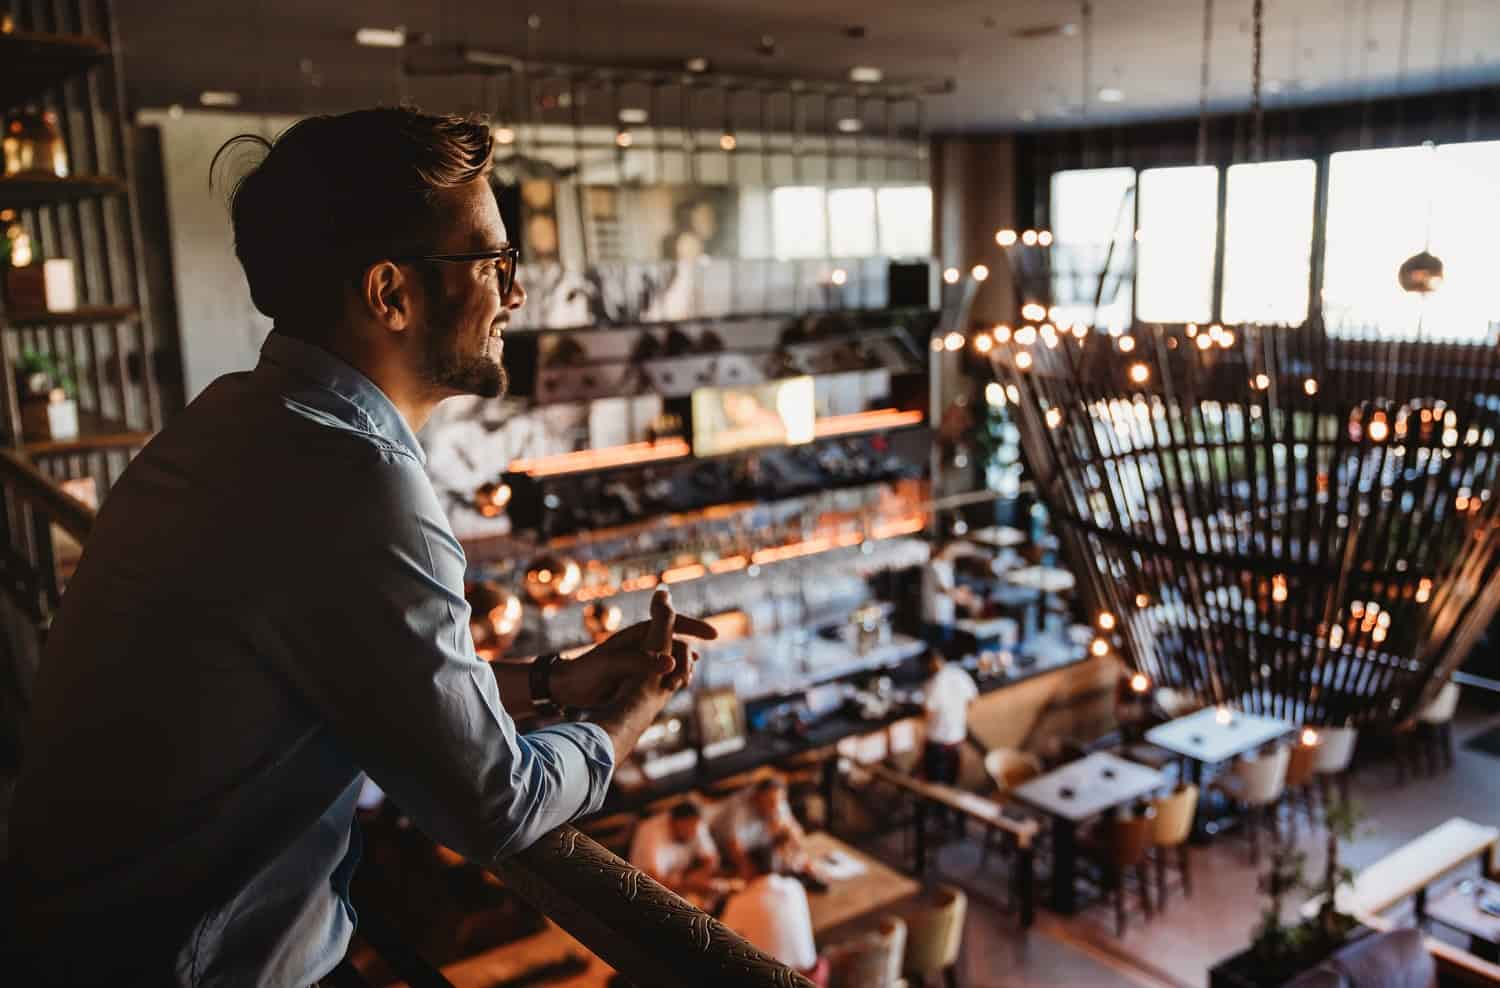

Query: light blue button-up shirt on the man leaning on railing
[{"left": 11, "top": 333, "right": 614, "bottom": 985}]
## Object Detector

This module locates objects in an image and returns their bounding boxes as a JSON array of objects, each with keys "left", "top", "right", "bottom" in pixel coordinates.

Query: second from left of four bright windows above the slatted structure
[{"left": 1136, "top": 165, "right": 1218, "bottom": 322}]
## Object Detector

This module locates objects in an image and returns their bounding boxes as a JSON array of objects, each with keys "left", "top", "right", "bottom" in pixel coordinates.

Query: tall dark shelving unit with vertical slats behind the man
[{"left": 0, "top": 0, "right": 161, "bottom": 495}]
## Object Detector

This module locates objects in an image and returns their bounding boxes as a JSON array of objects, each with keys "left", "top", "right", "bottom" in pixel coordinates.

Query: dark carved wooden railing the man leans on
[{"left": 0, "top": 450, "right": 812, "bottom": 988}]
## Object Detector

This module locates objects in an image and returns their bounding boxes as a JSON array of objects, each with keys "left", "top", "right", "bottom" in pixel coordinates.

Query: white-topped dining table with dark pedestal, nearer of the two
[{"left": 1011, "top": 751, "right": 1172, "bottom": 916}]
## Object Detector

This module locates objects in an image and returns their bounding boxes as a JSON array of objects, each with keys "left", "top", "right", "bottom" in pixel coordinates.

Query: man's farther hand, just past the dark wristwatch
[{"left": 552, "top": 589, "right": 719, "bottom": 708}]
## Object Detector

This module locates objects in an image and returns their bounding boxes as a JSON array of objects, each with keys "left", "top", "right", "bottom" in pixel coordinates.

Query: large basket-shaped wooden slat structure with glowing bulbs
[{"left": 990, "top": 321, "right": 1500, "bottom": 724}]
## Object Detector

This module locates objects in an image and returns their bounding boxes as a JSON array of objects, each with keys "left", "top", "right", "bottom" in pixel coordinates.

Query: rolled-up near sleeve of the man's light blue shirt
[{"left": 275, "top": 450, "right": 614, "bottom": 861}]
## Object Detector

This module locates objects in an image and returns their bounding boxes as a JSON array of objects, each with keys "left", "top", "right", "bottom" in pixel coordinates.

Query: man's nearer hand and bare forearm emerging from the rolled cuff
[{"left": 594, "top": 589, "right": 714, "bottom": 765}]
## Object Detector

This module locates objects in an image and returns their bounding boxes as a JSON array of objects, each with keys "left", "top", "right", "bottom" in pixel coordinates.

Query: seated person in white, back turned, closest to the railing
[{"left": 720, "top": 844, "right": 828, "bottom": 985}]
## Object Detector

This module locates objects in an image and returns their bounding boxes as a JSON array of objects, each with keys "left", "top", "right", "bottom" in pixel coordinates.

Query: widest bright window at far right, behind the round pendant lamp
[{"left": 1323, "top": 141, "right": 1500, "bottom": 340}]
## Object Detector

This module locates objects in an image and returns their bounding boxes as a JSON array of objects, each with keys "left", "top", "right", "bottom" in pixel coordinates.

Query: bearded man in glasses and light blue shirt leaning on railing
[{"left": 11, "top": 109, "right": 713, "bottom": 985}]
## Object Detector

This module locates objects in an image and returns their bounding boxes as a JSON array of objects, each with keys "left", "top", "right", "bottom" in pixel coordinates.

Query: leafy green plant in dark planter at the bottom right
[{"left": 1209, "top": 802, "right": 1367, "bottom": 988}]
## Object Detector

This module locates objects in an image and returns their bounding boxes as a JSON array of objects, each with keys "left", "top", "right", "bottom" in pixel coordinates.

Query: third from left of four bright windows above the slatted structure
[{"left": 1221, "top": 160, "right": 1317, "bottom": 324}]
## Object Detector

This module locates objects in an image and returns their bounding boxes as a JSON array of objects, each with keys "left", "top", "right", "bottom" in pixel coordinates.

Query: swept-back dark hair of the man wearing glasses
[{"left": 210, "top": 106, "right": 492, "bottom": 334}]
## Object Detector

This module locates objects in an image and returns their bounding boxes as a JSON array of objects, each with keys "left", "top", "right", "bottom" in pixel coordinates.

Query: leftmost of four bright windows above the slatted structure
[{"left": 1052, "top": 168, "right": 1136, "bottom": 330}]
